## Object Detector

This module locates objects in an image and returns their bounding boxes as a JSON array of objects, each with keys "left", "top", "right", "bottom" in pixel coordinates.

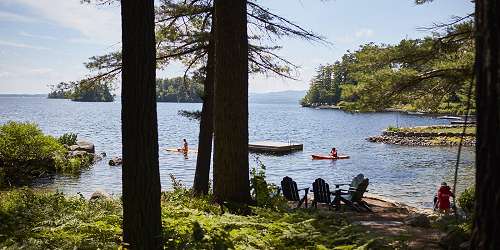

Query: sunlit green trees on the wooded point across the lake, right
[{"left": 301, "top": 20, "right": 475, "bottom": 114}]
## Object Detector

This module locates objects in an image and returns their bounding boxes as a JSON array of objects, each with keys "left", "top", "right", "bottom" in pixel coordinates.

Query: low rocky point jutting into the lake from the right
[{"left": 367, "top": 125, "right": 476, "bottom": 147}]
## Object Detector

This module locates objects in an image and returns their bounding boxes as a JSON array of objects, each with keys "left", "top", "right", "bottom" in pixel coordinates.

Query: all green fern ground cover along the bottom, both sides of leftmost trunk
[{"left": 0, "top": 188, "right": 400, "bottom": 249}]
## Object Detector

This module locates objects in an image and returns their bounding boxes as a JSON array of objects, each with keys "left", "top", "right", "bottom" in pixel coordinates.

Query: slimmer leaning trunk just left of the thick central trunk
[{"left": 193, "top": 30, "right": 215, "bottom": 195}]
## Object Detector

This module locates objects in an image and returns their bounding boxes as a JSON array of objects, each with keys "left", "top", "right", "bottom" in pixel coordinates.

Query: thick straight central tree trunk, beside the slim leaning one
[{"left": 213, "top": 0, "right": 250, "bottom": 203}]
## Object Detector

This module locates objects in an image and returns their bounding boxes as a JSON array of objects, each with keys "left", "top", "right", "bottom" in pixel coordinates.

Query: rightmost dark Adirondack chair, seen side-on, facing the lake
[{"left": 332, "top": 175, "right": 372, "bottom": 212}]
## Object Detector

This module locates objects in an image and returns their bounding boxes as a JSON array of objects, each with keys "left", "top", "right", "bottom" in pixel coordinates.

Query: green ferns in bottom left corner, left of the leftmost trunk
[{"left": 0, "top": 189, "right": 122, "bottom": 249}]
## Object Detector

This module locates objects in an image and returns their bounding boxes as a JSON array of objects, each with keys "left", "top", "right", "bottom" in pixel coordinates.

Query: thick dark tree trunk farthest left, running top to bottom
[{"left": 121, "top": 0, "right": 161, "bottom": 249}]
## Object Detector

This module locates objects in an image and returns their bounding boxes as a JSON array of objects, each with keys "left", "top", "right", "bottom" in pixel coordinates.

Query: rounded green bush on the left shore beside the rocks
[{"left": 0, "top": 121, "right": 94, "bottom": 187}]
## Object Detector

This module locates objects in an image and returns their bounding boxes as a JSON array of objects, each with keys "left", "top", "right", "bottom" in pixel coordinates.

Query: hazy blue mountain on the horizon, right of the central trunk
[{"left": 249, "top": 90, "right": 306, "bottom": 105}]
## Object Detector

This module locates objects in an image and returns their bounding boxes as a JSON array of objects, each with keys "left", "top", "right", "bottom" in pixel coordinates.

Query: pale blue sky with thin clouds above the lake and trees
[{"left": 0, "top": 0, "right": 474, "bottom": 94}]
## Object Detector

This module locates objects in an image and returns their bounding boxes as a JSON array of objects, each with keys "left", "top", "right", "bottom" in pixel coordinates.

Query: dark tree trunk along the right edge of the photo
[{"left": 471, "top": 0, "right": 500, "bottom": 249}]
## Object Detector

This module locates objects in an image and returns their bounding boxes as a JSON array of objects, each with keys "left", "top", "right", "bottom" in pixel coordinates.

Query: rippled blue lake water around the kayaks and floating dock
[{"left": 0, "top": 97, "right": 474, "bottom": 207}]
